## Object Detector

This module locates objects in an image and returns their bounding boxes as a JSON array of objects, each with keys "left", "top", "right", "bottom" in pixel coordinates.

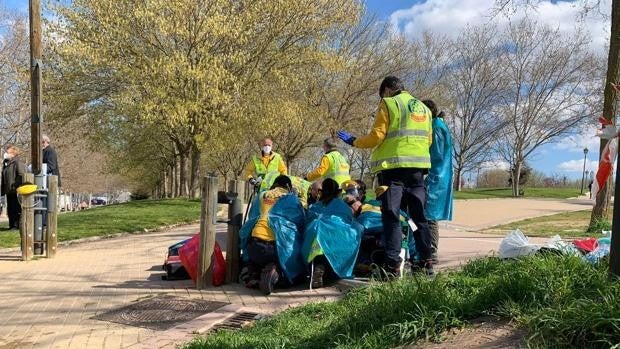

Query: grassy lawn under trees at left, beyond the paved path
[{"left": 0, "top": 199, "right": 200, "bottom": 248}]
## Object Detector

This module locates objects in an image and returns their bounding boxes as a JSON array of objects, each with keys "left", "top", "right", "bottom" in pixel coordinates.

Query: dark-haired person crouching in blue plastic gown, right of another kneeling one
[{"left": 302, "top": 178, "right": 363, "bottom": 288}]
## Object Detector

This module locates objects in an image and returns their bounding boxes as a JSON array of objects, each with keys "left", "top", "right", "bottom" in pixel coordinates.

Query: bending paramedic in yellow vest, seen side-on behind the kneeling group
[{"left": 306, "top": 138, "right": 351, "bottom": 185}]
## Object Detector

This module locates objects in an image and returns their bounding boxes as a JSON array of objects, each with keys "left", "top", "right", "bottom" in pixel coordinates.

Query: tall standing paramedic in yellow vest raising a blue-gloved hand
[{"left": 338, "top": 76, "right": 433, "bottom": 275}]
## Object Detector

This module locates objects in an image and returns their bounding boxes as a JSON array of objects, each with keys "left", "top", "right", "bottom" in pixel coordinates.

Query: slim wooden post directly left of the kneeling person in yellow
[{"left": 226, "top": 180, "right": 245, "bottom": 282}]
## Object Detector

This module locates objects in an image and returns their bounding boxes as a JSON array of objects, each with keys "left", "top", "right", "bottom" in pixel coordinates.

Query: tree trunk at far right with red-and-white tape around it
[{"left": 590, "top": 0, "right": 620, "bottom": 228}]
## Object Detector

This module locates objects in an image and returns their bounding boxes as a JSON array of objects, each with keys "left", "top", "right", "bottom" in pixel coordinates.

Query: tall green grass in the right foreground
[{"left": 183, "top": 255, "right": 620, "bottom": 349}]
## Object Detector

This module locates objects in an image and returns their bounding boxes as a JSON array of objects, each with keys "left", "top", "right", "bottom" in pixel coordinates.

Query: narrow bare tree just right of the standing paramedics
[{"left": 446, "top": 25, "right": 506, "bottom": 190}]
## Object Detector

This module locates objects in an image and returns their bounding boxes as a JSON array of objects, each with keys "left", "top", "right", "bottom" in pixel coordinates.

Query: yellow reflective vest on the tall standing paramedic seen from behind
[{"left": 370, "top": 92, "right": 433, "bottom": 173}]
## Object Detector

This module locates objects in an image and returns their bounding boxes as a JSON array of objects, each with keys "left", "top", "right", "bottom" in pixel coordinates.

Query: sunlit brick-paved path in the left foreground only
[{"left": 0, "top": 225, "right": 340, "bottom": 349}]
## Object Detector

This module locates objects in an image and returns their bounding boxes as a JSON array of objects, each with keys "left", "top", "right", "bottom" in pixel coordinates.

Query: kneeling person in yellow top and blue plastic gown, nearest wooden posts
[{"left": 240, "top": 175, "right": 304, "bottom": 294}]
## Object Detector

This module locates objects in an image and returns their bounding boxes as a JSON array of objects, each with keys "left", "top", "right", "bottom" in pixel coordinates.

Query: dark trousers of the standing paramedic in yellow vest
[{"left": 379, "top": 168, "right": 431, "bottom": 268}]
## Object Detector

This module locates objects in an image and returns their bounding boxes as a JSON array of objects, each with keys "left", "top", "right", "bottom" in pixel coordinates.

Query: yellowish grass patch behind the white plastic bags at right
[{"left": 484, "top": 210, "right": 611, "bottom": 238}]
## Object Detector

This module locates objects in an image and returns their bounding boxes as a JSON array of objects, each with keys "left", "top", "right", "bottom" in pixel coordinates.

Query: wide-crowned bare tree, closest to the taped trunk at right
[{"left": 496, "top": 20, "right": 600, "bottom": 196}]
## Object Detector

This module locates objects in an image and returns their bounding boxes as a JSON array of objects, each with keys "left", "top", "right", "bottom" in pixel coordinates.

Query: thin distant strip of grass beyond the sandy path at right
[{"left": 454, "top": 188, "right": 579, "bottom": 200}]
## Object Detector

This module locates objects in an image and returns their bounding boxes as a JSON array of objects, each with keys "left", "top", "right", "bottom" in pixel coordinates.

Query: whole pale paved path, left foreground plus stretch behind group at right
[{"left": 0, "top": 199, "right": 589, "bottom": 349}]
